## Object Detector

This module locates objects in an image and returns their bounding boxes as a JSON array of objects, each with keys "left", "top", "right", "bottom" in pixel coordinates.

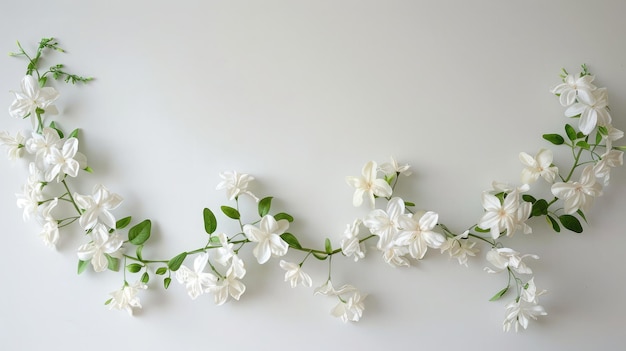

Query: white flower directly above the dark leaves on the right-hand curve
[{"left": 552, "top": 166, "right": 602, "bottom": 214}]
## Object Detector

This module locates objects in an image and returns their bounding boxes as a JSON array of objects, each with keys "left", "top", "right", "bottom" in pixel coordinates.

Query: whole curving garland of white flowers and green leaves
[{"left": 0, "top": 38, "right": 625, "bottom": 331}]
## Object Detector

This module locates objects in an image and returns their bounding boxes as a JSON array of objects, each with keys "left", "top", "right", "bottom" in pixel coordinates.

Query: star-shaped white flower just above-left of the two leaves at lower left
[{"left": 74, "top": 184, "right": 122, "bottom": 229}]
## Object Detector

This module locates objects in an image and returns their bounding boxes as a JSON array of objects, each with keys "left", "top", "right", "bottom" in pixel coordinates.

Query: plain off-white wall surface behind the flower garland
[{"left": 0, "top": 0, "right": 626, "bottom": 350}]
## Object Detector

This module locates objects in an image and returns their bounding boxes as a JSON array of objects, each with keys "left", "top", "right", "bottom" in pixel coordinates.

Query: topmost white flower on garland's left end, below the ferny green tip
[{"left": 9, "top": 76, "right": 59, "bottom": 129}]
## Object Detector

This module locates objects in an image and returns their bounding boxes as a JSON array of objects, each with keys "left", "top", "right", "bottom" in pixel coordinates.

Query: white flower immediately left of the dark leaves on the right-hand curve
[{"left": 478, "top": 190, "right": 532, "bottom": 239}]
